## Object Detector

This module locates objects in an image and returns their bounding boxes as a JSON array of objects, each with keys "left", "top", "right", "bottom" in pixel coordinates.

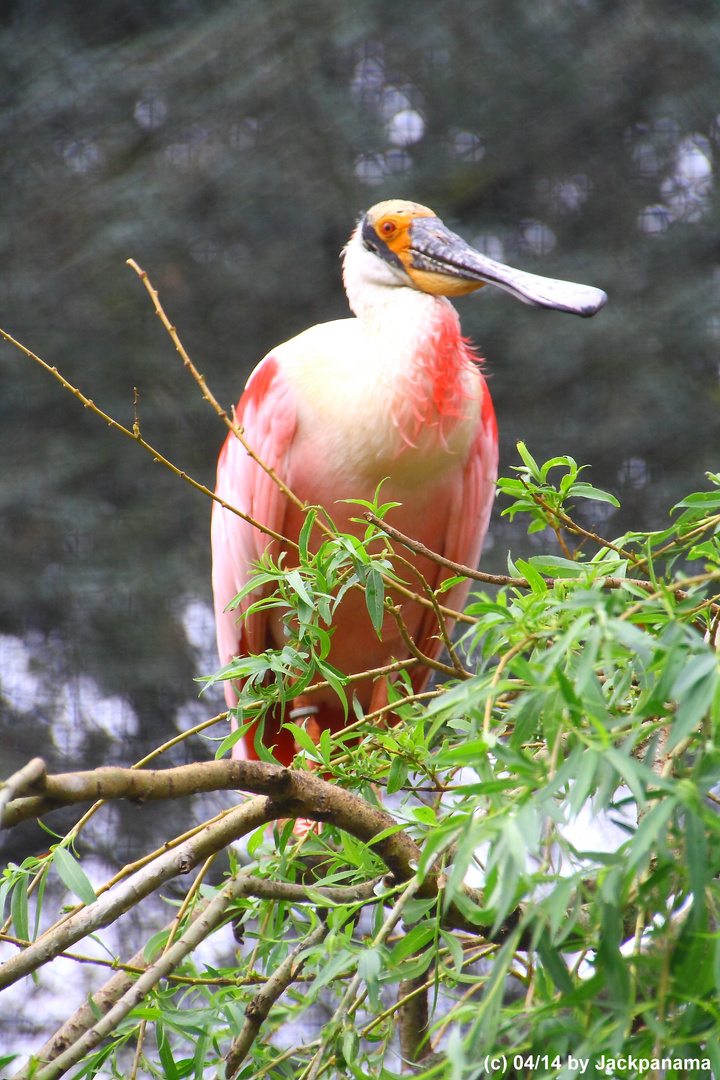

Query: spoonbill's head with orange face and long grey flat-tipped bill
[{"left": 344, "top": 199, "right": 608, "bottom": 318}]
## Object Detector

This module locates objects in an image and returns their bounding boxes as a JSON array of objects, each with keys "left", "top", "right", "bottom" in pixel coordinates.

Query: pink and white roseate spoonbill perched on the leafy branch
[{"left": 213, "top": 200, "right": 607, "bottom": 764}]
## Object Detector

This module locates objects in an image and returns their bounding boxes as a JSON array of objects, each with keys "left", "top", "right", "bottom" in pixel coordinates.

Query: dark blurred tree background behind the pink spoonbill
[{"left": 0, "top": 0, "right": 720, "bottom": 803}]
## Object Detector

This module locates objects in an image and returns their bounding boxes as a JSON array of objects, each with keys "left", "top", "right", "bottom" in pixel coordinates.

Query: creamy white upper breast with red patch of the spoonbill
[{"left": 275, "top": 319, "right": 487, "bottom": 502}]
